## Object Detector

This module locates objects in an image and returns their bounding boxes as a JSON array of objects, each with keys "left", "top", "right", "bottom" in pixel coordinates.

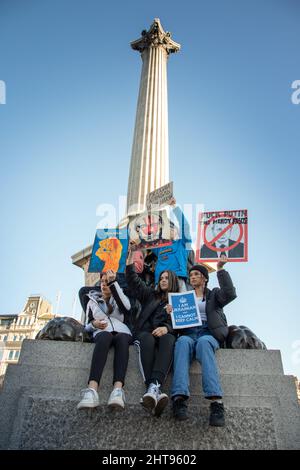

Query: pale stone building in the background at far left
[{"left": 0, "top": 295, "right": 54, "bottom": 385}]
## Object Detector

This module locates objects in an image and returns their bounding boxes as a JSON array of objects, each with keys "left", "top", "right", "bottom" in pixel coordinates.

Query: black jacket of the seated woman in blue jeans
[{"left": 180, "top": 269, "right": 237, "bottom": 345}]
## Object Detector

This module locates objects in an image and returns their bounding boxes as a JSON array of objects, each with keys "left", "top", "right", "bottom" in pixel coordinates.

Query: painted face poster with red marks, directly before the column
[{"left": 128, "top": 210, "right": 172, "bottom": 249}]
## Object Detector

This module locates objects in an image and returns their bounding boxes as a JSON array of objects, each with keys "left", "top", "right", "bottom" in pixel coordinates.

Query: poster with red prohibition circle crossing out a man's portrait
[{"left": 196, "top": 209, "right": 248, "bottom": 263}]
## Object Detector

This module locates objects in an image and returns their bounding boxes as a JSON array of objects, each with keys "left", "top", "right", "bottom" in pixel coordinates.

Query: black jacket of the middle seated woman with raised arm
[{"left": 126, "top": 264, "right": 176, "bottom": 336}]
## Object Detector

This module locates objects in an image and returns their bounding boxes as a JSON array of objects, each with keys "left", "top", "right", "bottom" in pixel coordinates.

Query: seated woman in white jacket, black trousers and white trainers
[{"left": 77, "top": 270, "right": 132, "bottom": 410}]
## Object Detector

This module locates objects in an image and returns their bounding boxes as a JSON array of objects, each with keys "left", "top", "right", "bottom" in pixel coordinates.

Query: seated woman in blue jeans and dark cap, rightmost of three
[{"left": 166, "top": 256, "right": 236, "bottom": 426}]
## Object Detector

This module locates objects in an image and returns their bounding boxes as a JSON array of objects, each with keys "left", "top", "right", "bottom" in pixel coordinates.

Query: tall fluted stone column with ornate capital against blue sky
[{"left": 127, "top": 18, "right": 180, "bottom": 215}]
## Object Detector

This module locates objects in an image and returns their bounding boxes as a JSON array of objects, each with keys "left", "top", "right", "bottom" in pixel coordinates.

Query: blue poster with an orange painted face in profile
[{"left": 88, "top": 227, "right": 128, "bottom": 273}]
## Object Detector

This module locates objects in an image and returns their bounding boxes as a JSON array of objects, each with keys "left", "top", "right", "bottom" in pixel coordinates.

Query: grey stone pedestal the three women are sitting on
[{"left": 0, "top": 340, "right": 300, "bottom": 450}]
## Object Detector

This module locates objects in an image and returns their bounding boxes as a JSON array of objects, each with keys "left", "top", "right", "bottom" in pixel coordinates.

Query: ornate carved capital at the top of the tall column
[{"left": 130, "top": 18, "right": 181, "bottom": 54}]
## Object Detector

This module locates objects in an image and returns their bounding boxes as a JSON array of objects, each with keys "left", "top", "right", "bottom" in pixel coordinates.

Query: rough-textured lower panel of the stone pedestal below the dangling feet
[{"left": 9, "top": 397, "right": 278, "bottom": 450}]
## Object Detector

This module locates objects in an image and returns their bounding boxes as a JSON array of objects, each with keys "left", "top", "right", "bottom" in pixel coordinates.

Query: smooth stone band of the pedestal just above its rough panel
[{"left": 2, "top": 364, "right": 295, "bottom": 403}]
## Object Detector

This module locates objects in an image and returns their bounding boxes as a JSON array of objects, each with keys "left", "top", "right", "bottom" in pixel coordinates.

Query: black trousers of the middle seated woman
[{"left": 136, "top": 331, "right": 176, "bottom": 386}]
